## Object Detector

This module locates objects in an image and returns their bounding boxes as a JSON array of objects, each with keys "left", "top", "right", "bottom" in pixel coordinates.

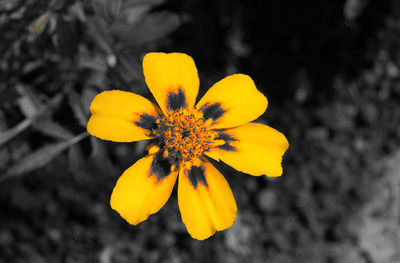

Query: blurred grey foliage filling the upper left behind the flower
[{"left": 0, "top": 0, "right": 181, "bottom": 180}]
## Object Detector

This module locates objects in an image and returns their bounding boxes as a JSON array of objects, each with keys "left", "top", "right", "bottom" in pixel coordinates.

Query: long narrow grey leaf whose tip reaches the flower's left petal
[{"left": 0, "top": 132, "right": 88, "bottom": 180}]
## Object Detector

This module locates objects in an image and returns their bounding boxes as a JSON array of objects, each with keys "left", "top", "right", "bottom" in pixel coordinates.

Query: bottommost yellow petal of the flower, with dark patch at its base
[{"left": 178, "top": 161, "right": 237, "bottom": 240}]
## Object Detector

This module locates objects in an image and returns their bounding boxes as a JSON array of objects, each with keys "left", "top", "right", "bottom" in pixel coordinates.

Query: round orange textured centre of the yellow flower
[{"left": 156, "top": 109, "right": 218, "bottom": 165}]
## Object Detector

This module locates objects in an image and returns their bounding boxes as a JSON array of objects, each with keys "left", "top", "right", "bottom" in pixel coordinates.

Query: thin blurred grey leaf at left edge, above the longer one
[{"left": 0, "top": 94, "right": 63, "bottom": 147}]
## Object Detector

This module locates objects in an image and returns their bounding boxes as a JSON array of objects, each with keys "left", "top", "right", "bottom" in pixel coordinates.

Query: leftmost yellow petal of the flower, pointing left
[{"left": 87, "top": 90, "right": 159, "bottom": 142}]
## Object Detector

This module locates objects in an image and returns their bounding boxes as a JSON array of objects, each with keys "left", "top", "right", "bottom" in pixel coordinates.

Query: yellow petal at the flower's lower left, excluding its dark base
[{"left": 110, "top": 155, "right": 177, "bottom": 225}]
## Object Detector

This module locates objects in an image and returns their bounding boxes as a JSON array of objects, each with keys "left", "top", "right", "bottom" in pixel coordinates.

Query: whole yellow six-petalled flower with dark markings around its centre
[{"left": 87, "top": 53, "right": 289, "bottom": 240}]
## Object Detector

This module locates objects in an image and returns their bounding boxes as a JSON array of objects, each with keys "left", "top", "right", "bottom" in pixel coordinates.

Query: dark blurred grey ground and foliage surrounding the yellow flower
[{"left": 0, "top": 0, "right": 400, "bottom": 263}]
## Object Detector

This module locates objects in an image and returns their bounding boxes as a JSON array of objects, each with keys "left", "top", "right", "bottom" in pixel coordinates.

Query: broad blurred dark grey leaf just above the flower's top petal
[{"left": 119, "top": 12, "right": 181, "bottom": 47}]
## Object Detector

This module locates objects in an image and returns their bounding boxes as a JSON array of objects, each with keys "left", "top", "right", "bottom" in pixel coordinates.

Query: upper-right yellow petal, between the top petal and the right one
[{"left": 196, "top": 74, "right": 268, "bottom": 129}]
